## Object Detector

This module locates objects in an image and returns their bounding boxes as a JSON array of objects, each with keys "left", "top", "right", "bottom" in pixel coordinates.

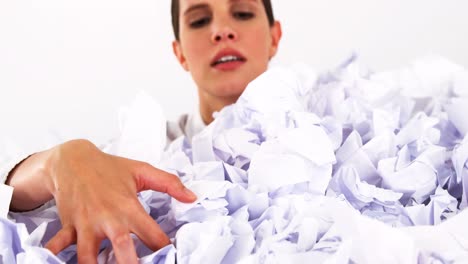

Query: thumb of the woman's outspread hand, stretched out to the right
[{"left": 133, "top": 163, "right": 197, "bottom": 203}]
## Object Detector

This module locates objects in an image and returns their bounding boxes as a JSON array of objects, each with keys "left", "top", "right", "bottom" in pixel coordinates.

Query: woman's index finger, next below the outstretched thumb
[{"left": 130, "top": 207, "right": 171, "bottom": 251}]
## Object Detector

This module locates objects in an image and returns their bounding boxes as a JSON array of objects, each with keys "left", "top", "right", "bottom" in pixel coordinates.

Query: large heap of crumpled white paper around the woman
[{"left": 0, "top": 56, "right": 468, "bottom": 263}]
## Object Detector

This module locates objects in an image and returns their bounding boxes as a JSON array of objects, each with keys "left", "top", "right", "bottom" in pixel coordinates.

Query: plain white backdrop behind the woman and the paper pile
[{"left": 0, "top": 0, "right": 468, "bottom": 143}]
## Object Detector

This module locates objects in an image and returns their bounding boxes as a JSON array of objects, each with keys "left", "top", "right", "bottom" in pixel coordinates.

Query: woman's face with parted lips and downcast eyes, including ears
[{"left": 173, "top": 0, "right": 281, "bottom": 104}]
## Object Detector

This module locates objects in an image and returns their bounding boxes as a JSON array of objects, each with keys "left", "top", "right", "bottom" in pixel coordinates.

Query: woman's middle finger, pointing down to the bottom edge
[{"left": 104, "top": 224, "right": 138, "bottom": 264}]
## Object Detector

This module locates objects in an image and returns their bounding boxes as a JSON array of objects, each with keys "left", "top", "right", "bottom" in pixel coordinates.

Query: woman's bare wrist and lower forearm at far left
[{"left": 6, "top": 149, "right": 53, "bottom": 211}]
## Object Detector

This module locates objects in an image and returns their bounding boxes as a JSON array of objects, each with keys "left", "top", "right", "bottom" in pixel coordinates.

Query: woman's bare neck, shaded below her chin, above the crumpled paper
[{"left": 198, "top": 92, "right": 237, "bottom": 125}]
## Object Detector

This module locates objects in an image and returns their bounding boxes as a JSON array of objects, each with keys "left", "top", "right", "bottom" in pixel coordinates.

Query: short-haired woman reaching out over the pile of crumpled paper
[{"left": 3, "top": 0, "right": 281, "bottom": 263}]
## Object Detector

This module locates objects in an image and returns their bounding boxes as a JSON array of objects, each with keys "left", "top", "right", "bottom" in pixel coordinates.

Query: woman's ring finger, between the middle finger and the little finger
[{"left": 77, "top": 229, "right": 100, "bottom": 263}]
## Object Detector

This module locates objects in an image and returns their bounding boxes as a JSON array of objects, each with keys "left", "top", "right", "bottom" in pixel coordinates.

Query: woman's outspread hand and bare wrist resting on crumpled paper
[{"left": 7, "top": 140, "right": 196, "bottom": 263}]
